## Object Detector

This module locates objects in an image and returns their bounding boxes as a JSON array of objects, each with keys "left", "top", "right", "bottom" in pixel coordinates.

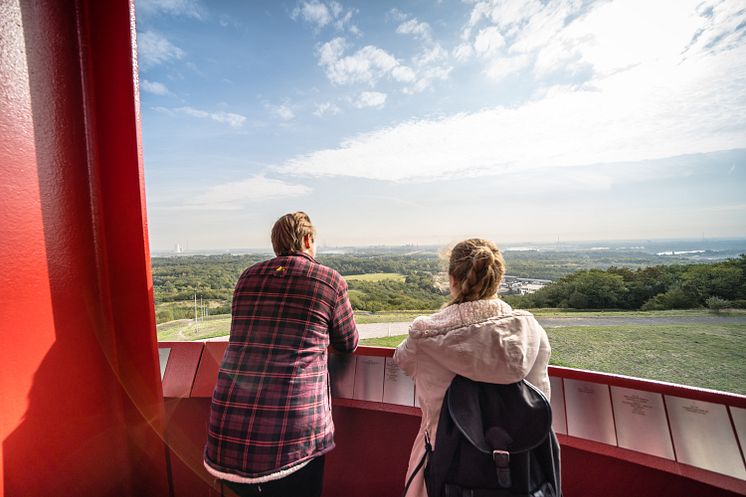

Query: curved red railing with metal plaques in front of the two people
[{"left": 159, "top": 342, "right": 746, "bottom": 497}]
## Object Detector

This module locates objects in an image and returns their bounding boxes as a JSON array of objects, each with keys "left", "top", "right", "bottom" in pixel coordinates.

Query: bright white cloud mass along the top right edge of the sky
[{"left": 453, "top": 0, "right": 746, "bottom": 83}]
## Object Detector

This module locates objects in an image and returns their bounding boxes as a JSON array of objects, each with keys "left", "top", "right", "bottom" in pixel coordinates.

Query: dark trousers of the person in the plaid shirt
[{"left": 220, "top": 456, "right": 325, "bottom": 497}]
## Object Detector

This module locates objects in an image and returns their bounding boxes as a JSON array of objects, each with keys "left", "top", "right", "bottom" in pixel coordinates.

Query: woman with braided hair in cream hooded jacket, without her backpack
[{"left": 394, "top": 238, "right": 550, "bottom": 497}]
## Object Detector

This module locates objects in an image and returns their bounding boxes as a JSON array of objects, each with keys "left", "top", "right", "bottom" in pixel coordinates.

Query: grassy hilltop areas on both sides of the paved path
[{"left": 158, "top": 310, "right": 746, "bottom": 395}]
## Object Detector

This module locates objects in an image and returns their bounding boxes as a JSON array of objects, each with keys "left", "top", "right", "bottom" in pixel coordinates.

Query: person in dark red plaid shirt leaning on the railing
[{"left": 204, "top": 212, "right": 358, "bottom": 497}]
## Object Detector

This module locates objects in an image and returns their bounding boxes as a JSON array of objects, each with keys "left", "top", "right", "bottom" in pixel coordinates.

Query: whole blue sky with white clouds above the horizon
[{"left": 136, "top": 0, "right": 746, "bottom": 250}]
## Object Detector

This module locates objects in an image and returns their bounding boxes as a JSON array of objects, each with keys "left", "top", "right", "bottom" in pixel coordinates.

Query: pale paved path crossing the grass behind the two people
[{"left": 202, "top": 315, "right": 746, "bottom": 342}]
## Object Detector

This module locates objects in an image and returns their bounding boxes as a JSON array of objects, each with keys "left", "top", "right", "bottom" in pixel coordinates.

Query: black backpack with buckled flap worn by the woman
[{"left": 404, "top": 376, "right": 562, "bottom": 497}]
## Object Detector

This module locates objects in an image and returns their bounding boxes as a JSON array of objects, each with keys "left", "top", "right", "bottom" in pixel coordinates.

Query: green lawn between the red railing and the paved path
[{"left": 363, "top": 324, "right": 746, "bottom": 394}]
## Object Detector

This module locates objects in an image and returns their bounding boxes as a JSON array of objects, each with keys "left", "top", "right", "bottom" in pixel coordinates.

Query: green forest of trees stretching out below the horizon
[{"left": 152, "top": 253, "right": 746, "bottom": 322}]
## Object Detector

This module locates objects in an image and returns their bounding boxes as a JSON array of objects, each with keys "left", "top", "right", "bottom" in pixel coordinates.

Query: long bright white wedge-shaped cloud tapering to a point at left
[{"left": 279, "top": 40, "right": 746, "bottom": 181}]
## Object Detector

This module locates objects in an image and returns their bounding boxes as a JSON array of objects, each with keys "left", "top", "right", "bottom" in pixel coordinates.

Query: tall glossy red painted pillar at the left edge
[{"left": 0, "top": 0, "right": 169, "bottom": 497}]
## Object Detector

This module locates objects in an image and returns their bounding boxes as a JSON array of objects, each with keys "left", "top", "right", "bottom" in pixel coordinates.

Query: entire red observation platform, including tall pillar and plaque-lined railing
[{"left": 0, "top": 0, "right": 746, "bottom": 497}]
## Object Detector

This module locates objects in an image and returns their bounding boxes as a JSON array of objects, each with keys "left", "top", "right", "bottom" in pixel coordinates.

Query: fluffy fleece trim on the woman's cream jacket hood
[{"left": 409, "top": 298, "right": 513, "bottom": 338}]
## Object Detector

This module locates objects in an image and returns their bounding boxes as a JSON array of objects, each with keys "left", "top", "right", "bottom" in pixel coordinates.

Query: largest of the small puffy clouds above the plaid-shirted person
[{"left": 317, "top": 38, "right": 413, "bottom": 86}]
